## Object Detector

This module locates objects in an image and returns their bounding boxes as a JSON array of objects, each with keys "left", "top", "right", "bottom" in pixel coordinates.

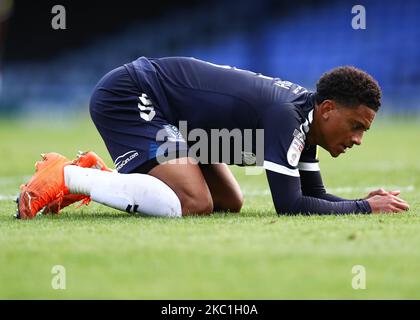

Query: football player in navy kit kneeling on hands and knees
[{"left": 17, "top": 57, "right": 409, "bottom": 219}]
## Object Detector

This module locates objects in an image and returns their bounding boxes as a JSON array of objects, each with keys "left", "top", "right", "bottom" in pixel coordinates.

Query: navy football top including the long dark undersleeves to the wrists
[{"left": 119, "top": 57, "right": 371, "bottom": 214}]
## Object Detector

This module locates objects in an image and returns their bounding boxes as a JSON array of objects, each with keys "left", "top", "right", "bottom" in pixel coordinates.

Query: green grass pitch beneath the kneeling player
[{"left": 0, "top": 118, "right": 420, "bottom": 299}]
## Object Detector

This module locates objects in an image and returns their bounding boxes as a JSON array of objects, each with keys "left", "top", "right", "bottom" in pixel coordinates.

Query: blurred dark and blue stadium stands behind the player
[{"left": 0, "top": 0, "right": 420, "bottom": 117}]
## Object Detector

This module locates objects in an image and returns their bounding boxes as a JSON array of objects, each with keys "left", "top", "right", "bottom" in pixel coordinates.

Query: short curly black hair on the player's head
[{"left": 316, "top": 66, "right": 381, "bottom": 111}]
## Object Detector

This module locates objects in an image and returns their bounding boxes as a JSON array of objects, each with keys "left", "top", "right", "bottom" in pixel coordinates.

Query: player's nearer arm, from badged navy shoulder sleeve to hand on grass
[{"left": 262, "top": 104, "right": 408, "bottom": 214}]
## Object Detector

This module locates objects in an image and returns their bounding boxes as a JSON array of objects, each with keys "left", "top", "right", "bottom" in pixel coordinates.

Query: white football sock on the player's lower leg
[{"left": 64, "top": 165, "right": 182, "bottom": 217}]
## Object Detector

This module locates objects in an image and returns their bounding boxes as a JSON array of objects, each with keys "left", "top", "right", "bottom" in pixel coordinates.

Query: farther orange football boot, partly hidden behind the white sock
[{"left": 42, "top": 151, "right": 112, "bottom": 214}]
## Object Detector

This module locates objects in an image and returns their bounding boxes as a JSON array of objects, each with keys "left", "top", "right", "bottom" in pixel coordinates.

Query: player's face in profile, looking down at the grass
[{"left": 323, "top": 102, "right": 375, "bottom": 158}]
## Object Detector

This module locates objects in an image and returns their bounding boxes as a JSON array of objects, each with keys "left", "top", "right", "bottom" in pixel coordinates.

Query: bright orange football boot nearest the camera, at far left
[{"left": 16, "top": 152, "right": 72, "bottom": 219}]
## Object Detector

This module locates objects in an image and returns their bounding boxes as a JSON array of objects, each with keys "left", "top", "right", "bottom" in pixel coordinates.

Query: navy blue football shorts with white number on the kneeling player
[{"left": 90, "top": 66, "right": 188, "bottom": 173}]
